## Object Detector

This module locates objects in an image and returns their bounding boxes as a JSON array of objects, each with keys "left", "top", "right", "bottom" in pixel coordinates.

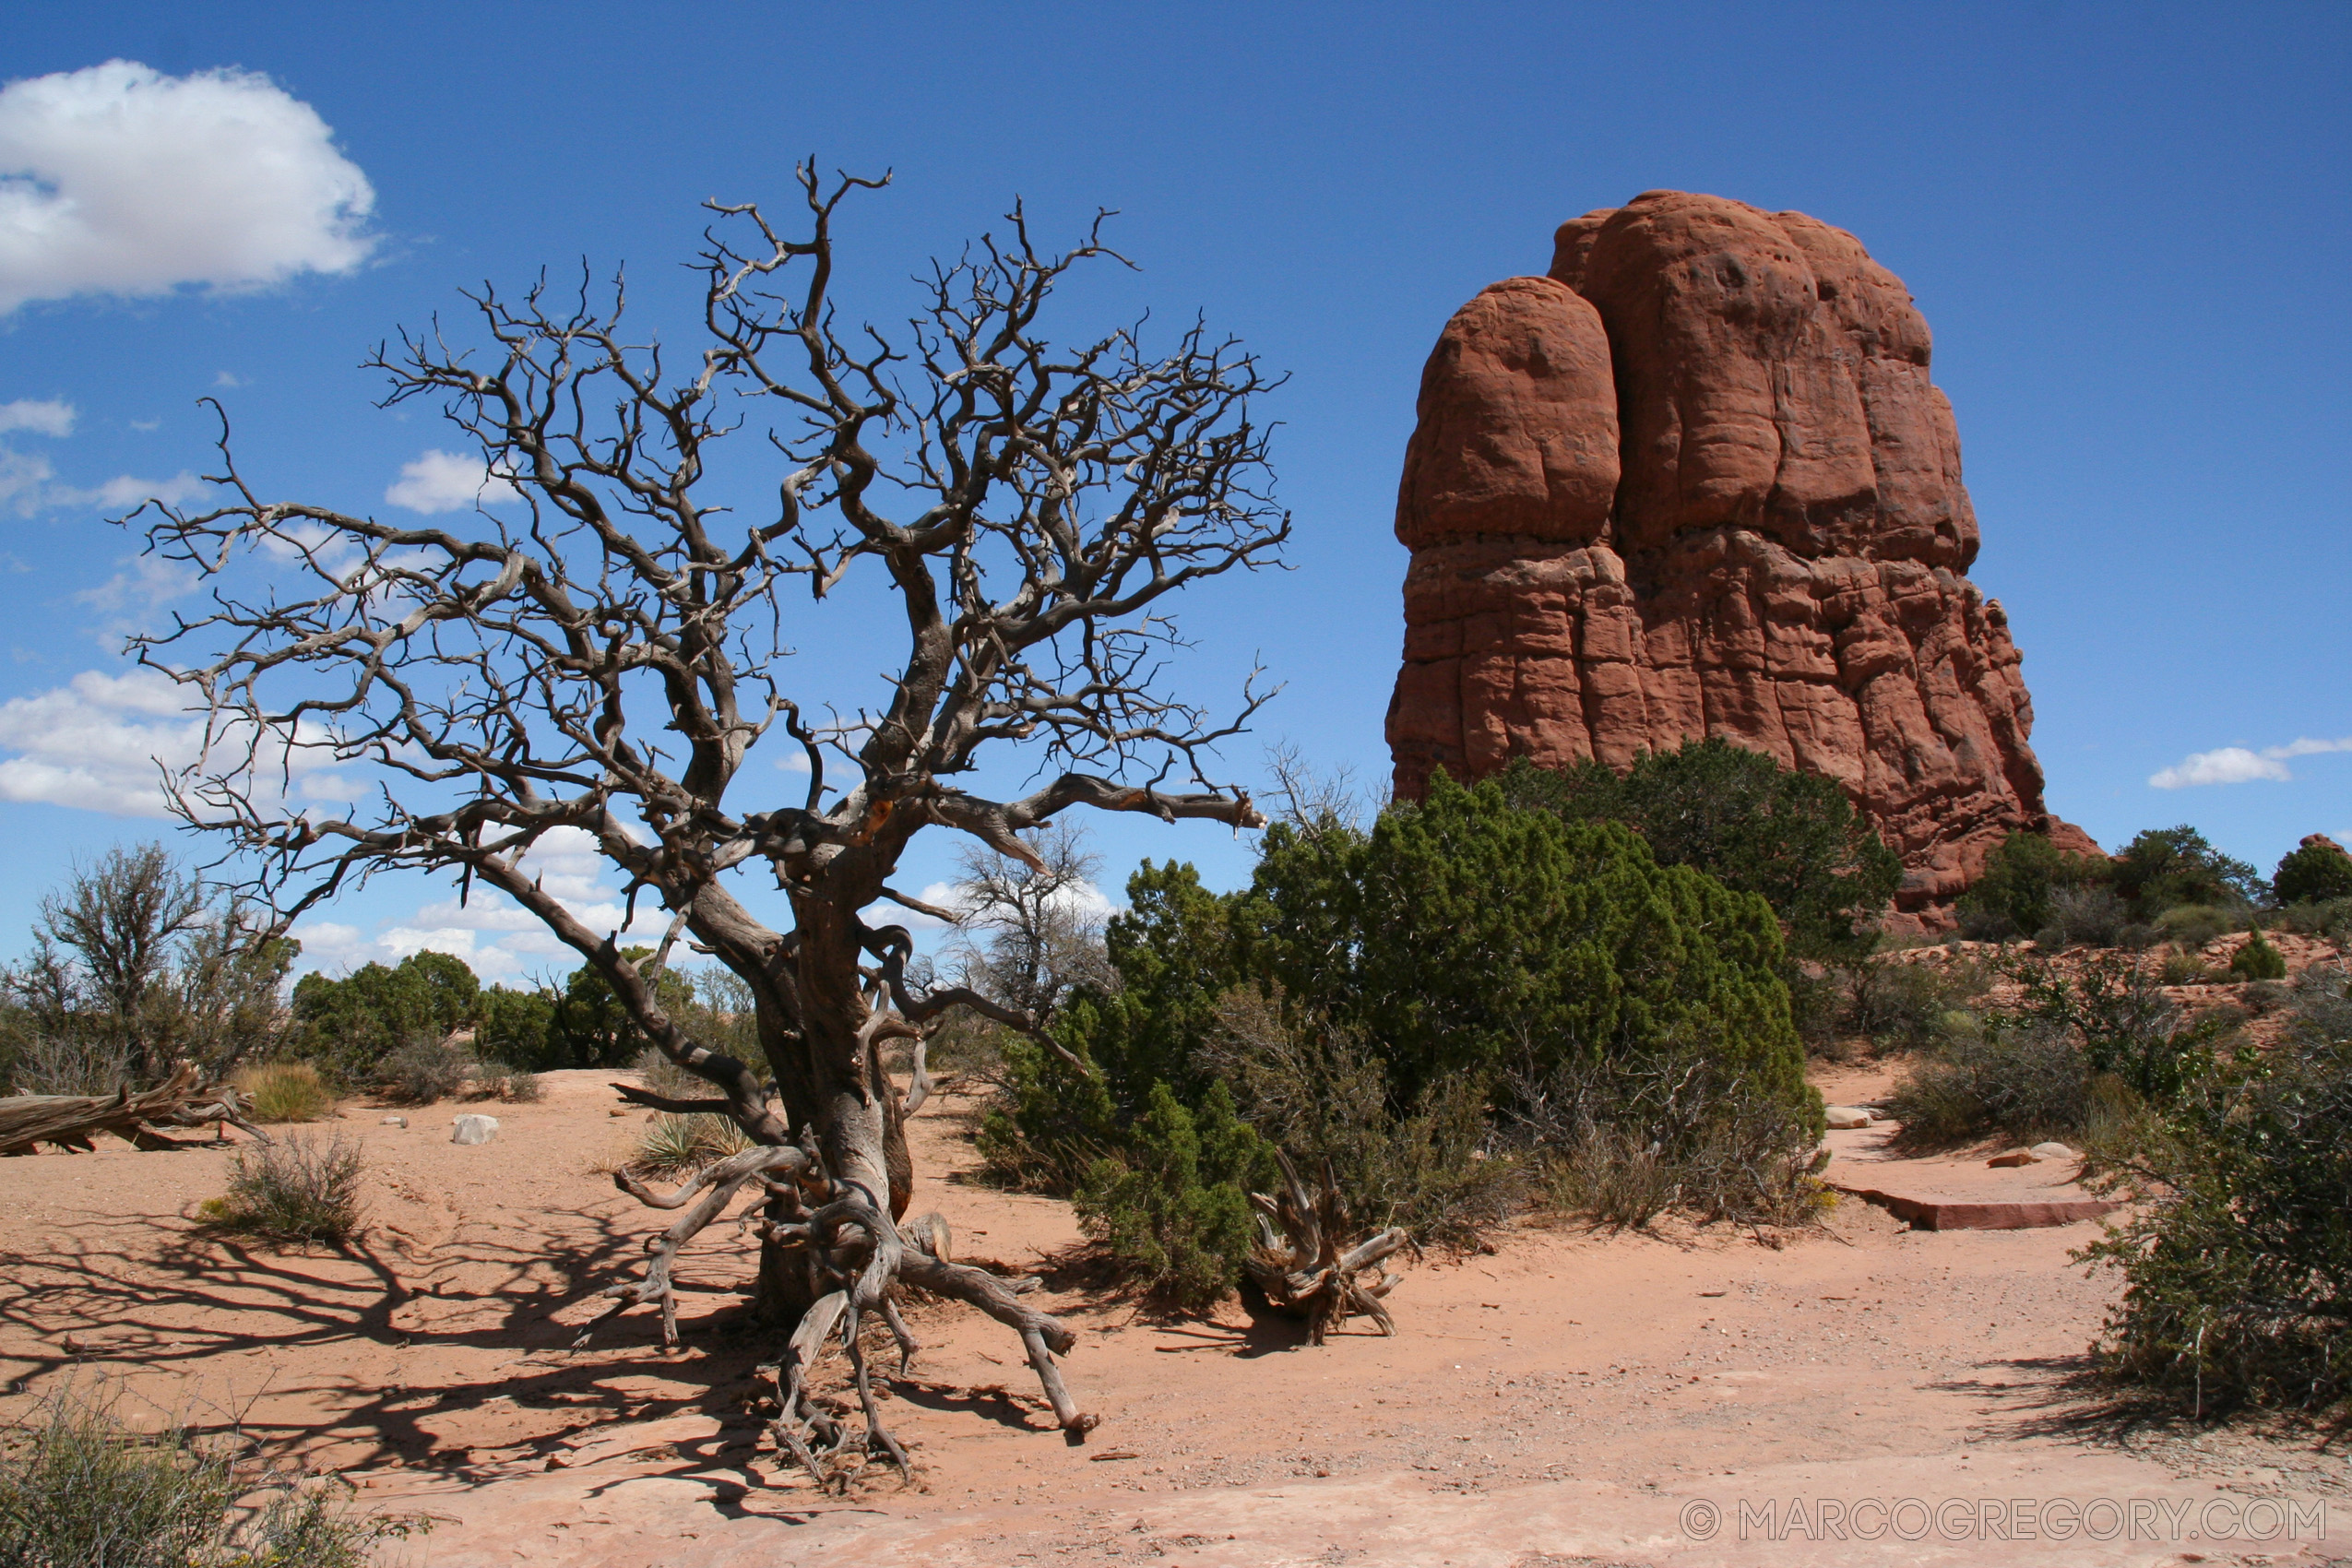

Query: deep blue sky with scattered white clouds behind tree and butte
[{"left": 0, "top": 3, "right": 2352, "bottom": 968}]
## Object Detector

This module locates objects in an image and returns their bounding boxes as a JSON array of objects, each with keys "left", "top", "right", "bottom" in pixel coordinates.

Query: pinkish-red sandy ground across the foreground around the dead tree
[{"left": 0, "top": 1072, "right": 2352, "bottom": 1568}]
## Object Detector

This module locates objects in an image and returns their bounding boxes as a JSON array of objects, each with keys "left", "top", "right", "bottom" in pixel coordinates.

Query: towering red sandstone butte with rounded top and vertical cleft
[{"left": 1388, "top": 190, "right": 2098, "bottom": 926}]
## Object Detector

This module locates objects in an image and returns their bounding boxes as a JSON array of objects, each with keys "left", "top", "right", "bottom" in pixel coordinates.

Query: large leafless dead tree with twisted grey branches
[{"left": 128, "top": 164, "right": 1289, "bottom": 1453}]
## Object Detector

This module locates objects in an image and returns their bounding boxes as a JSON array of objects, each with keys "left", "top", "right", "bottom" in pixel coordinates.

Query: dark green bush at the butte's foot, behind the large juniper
[{"left": 1498, "top": 738, "right": 1903, "bottom": 959}]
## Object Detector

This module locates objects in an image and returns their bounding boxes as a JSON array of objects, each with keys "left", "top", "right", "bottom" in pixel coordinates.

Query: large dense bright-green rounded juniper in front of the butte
[{"left": 1235, "top": 776, "right": 1812, "bottom": 1105}]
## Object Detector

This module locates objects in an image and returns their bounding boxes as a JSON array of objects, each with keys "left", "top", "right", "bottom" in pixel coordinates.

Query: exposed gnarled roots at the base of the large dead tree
[{"left": 572, "top": 1145, "right": 1096, "bottom": 1486}]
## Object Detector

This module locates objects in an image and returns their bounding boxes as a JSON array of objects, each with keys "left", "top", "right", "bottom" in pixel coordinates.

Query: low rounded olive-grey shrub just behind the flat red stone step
[{"left": 1886, "top": 1020, "right": 2091, "bottom": 1149}]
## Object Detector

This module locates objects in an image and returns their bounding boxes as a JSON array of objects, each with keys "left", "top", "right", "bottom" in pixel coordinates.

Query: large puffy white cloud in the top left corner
[{"left": 0, "top": 59, "right": 376, "bottom": 313}]
